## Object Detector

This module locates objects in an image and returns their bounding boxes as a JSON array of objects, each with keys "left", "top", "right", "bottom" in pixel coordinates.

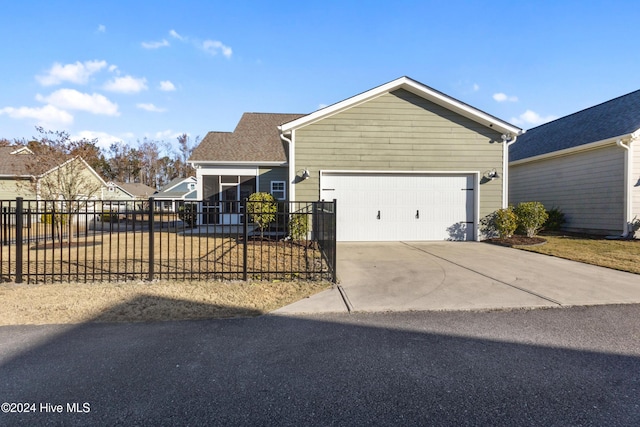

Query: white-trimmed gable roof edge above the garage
[{"left": 280, "top": 76, "right": 522, "bottom": 135}]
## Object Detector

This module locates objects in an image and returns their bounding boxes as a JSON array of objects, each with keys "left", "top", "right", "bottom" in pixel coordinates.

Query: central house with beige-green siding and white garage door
[{"left": 190, "top": 77, "right": 522, "bottom": 241}]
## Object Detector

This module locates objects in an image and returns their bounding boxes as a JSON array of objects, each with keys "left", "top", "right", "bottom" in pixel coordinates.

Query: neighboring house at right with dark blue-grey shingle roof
[{"left": 509, "top": 90, "right": 640, "bottom": 237}]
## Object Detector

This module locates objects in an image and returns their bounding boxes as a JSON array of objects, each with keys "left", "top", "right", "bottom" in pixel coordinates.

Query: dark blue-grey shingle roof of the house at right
[{"left": 509, "top": 90, "right": 640, "bottom": 162}]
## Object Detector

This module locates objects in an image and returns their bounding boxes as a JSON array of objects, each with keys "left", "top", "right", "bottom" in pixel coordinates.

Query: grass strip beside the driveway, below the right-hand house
[{"left": 514, "top": 235, "right": 640, "bottom": 274}]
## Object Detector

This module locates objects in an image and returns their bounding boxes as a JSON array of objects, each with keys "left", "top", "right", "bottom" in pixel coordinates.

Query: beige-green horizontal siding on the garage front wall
[{"left": 293, "top": 89, "right": 502, "bottom": 217}]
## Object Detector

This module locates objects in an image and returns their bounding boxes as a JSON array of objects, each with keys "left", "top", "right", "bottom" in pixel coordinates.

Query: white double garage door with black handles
[{"left": 320, "top": 172, "right": 475, "bottom": 241}]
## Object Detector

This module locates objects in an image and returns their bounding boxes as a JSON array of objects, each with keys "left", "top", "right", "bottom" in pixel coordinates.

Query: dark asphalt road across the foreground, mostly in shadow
[{"left": 0, "top": 305, "right": 640, "bottom": 426}]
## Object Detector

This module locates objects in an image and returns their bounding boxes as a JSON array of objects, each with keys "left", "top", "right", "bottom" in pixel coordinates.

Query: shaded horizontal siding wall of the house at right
[{"left": 509, "top": 145, "right": 624, "bottom": 234}]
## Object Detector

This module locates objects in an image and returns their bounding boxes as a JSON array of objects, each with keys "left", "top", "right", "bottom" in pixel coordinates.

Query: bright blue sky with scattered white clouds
[{"left": 0, "top": 0, "right": 640, "bottom": 152}]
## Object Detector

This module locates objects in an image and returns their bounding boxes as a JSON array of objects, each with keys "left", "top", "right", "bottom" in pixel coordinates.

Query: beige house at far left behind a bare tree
[{"left": 0, "top": 146, "right": 105, "bottom": 200}]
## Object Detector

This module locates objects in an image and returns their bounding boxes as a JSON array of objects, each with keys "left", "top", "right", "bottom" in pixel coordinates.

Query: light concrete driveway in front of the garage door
[{"left": 275, "top": 242, "right": 640, "bottom": 314}]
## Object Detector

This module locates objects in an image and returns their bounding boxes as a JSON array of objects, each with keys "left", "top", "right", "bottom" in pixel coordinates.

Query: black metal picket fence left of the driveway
[{"left": 0, "top": 198, "right": 336, "bottom": 283}]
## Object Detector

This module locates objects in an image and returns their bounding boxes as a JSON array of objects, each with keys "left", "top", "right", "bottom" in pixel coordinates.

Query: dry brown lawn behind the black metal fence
[{"left": 0, "top": 231, "right": 326, "bottom": 283}]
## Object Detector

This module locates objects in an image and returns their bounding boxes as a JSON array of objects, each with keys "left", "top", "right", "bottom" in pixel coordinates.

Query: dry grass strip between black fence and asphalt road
[{"left": 0, "top": 281, "right": 331, "bottom": 325}]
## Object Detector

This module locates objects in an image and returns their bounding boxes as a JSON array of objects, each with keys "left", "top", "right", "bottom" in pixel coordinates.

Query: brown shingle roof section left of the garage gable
[{"left": 189, "top": 113, "right": 303, "bottom": 163}]
